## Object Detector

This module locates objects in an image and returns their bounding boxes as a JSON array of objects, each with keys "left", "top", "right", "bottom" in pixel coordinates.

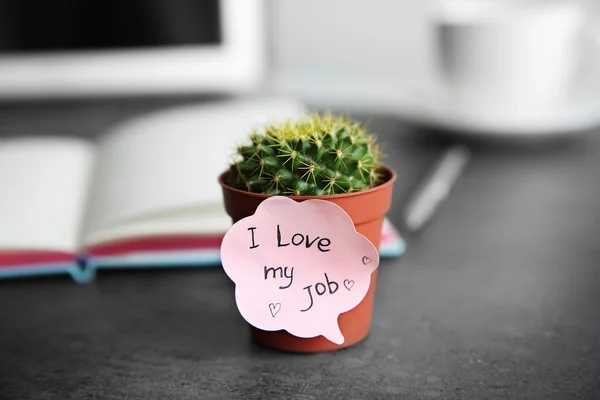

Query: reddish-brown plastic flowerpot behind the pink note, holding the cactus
[{"left": 219, "top": 166, "right": 396, "bottom": 352}]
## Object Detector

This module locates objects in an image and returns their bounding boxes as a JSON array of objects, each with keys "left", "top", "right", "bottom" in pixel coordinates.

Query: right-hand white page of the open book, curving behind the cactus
[{"left": 83, "top": 99, "right": 305, "bottom": 245}]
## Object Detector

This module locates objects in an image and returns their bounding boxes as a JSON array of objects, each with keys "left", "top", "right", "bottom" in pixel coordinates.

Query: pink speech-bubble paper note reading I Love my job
[{"left": 221, "top": 196, "right": 379, "bottom": 345}]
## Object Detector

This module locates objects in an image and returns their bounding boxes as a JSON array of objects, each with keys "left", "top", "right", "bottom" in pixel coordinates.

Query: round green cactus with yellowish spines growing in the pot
[{"left": 230, "top": 113, "right": 381, "bottom": 196}]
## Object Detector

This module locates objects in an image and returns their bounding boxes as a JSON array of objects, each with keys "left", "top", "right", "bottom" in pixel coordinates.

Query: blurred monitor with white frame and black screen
[{"left": 0, "top": 0, "right": 264, "bottom": 98}]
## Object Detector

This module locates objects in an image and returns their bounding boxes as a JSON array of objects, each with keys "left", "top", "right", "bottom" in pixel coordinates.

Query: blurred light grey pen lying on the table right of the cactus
[{"left": 404, "top": 146, "right": 470, "bottom": 231}]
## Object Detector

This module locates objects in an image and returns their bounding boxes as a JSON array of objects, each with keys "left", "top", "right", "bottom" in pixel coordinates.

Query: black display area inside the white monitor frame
[{"left": 0, "top": 0, "right": 222, "bottom": 54}]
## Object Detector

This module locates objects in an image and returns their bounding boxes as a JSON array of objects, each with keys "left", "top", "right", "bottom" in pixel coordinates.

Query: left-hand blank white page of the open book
[{"left": 0, "top": 138, "right": 94, "bottom": 252}]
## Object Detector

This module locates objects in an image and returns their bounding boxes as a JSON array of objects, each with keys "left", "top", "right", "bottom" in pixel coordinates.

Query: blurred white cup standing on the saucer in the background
[{"left": 432, "top": 0, "right": 585, "bottom": 118}]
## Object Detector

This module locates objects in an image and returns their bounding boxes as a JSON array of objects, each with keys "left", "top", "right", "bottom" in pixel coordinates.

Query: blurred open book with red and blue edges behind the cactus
[{"left": 0, "top": 99, "right": 404, "bottom": 282}]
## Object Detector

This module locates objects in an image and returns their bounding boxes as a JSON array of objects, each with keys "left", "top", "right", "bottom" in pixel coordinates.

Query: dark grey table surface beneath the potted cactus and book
[{"left": 0, "top": 100, "right": 600, "bottom": 400}]
